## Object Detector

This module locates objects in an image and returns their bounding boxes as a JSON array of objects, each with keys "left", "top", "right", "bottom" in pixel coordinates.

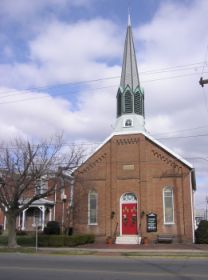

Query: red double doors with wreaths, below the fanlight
[{"left": 122, "top": 203, "right": 138, "bottom": 235}]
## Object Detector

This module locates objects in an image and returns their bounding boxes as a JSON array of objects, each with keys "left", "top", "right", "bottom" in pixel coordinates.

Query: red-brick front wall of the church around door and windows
[{"left": 74, "top": 134, "right": 192, "bottom": 242}]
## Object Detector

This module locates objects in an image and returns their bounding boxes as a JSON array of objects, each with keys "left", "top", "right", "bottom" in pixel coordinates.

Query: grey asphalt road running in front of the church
[{"left": 0, "top": 253, "right": 208, "bottom": 280}]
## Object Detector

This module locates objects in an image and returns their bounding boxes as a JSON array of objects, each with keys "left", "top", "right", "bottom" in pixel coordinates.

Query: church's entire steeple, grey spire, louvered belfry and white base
[{"left": 115, "top": 12, "right": 145, "bottom": 132}]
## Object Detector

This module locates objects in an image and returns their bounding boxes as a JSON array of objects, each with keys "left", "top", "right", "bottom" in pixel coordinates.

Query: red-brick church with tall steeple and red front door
[{"left": 73, "top": 16, "right": 195, "bottom": 244}]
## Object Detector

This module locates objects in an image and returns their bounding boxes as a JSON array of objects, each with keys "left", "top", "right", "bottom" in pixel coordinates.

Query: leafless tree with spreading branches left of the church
[{"left": 0, "top": 136, "right": 83, "bottom": 247}]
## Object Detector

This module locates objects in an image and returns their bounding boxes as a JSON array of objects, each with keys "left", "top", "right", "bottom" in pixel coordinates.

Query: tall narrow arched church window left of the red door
[{"left": 88, "top": 191, "right": 98, "bottom": 225}]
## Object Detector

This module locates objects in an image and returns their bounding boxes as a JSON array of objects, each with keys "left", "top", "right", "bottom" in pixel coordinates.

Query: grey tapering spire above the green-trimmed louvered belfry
[{"left": 120, "top": 11, "right": 140, "bottom": 90}]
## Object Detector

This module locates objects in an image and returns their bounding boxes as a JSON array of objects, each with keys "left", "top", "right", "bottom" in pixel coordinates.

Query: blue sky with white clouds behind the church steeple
[{"left": 0, "top": 0, "right": 208, "bottom": 209}]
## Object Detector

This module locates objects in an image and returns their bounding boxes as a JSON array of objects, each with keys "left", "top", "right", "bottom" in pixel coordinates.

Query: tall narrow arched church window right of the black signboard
[{"left": 163, "top": 187, "right": 174, "bottom": 224}]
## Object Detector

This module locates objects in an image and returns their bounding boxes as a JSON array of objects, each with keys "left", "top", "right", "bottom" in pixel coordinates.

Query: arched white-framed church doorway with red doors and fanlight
[{"left": 120, "top": 193, "right": 138, "bottom": 235}]
